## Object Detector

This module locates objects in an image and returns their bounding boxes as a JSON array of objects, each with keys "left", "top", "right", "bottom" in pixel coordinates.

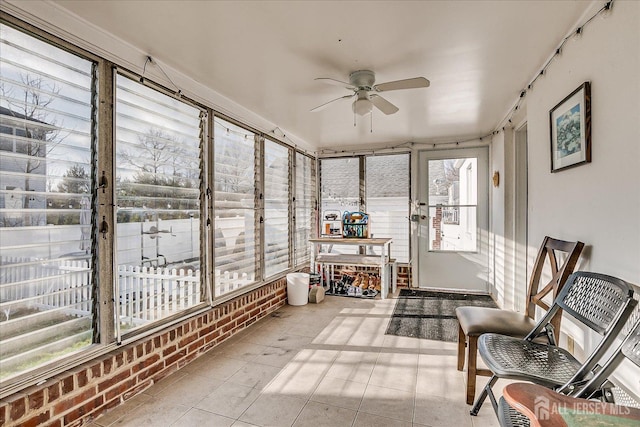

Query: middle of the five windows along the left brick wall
[{"left": 213, "top": 117, "right": 259, "bottom": 296}]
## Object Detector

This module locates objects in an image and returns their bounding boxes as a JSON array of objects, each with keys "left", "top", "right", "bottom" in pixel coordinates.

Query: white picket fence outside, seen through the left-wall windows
[{"left": 0, "top": 257, "right": 255, "bottom": 326}]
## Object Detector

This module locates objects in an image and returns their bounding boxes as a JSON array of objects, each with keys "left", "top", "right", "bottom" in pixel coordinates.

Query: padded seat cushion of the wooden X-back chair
[{"left": 456, "top": 307, "right": 536, "bottom": 338}]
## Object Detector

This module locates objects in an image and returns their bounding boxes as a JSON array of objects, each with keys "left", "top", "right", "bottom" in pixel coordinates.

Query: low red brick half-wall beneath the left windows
[{"left": 0, "top": 278, "right": 287, "bottom": 427}]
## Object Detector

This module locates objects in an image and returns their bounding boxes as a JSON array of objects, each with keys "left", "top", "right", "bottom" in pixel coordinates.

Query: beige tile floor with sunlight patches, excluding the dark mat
[{"left": 91, "top": 296, "right": 510, "bottom": 427}]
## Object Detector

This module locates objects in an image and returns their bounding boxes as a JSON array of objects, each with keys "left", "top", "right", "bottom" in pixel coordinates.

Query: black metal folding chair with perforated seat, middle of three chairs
[{"left": 470, "top": 272, "right": 637, "bottom": 415}]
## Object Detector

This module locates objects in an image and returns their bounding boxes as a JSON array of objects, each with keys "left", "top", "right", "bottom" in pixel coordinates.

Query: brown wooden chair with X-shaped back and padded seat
[{"left": 456, "top": 236, "right": 584, "bottom": 405}]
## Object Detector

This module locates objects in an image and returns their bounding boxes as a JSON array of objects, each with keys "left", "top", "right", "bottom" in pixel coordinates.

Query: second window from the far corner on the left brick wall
[{"left": 264, "top": 140, "right": 291, "bottom": 277}]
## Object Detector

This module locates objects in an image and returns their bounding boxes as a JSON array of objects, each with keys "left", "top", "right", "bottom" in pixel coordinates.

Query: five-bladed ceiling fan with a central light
[{"left": 311, "top": 70, "right": 430, "bottom": 116}]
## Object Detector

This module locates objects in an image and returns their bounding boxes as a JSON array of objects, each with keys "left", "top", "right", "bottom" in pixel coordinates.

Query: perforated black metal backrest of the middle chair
[{"left": 544, "top": 271, "right": 638, "bottom": 389}]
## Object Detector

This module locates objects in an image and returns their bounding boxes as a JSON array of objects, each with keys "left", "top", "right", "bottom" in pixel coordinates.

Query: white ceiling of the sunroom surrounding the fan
[{"left": 56, "top": 0, "right": 592, "bottom": 148}]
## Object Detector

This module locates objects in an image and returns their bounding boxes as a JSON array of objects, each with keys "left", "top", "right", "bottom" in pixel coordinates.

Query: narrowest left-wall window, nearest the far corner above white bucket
[{"left": 294, "top": 153, "right": 316, "bottom": 266}]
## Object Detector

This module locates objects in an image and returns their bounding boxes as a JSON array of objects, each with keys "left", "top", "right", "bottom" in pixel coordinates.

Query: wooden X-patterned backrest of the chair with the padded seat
[{"left": 525, "top": 236, "right": 584, "bottom": 340}]
